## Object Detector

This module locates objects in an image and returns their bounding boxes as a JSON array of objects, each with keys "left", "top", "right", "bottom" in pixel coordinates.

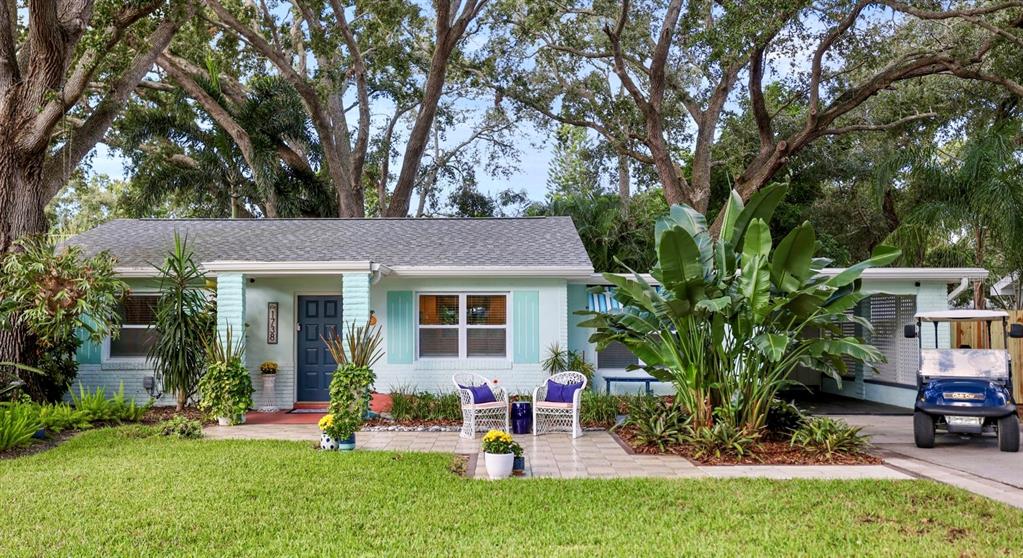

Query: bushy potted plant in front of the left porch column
[{"left": 198, "top": 327, "right": 253, "bottom": 426}]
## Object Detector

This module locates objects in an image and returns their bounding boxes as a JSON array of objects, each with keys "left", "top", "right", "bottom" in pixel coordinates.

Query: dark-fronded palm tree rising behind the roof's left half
[{"left": 115, "top": 77, "right": 336, "bottom": 217}]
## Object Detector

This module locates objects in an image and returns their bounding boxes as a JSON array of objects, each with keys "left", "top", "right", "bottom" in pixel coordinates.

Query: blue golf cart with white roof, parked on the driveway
[{"left": 904, "top": 310, "right": 1023, "bottom": 452}]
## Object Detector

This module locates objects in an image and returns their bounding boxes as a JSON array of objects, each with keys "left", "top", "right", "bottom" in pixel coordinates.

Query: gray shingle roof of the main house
[{"left": 69, "top": 217, "right": 591, "bottom": 267}]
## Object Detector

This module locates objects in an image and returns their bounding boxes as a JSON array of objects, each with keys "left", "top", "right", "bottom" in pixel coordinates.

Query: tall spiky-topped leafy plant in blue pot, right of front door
[{"left": 323, "top": 324, "right": 384, "bottom": 450}]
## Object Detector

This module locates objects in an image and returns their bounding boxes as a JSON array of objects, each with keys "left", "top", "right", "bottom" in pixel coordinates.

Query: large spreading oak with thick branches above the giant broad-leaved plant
[{"left": 481, "top": 0, "right": 1023, "bottom": 226}]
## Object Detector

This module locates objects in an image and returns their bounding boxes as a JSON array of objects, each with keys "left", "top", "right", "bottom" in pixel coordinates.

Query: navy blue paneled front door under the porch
[{"left": 298, "top": 296, "right": 341, "bottom": 401}]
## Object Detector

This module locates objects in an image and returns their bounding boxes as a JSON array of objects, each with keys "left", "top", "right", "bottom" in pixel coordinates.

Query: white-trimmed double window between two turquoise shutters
[{"left": 416, "top": 293, "right": 508, "bottom": 358}]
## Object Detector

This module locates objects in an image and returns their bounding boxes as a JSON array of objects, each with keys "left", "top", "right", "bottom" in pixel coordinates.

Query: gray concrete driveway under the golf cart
[{"left": 836, "top": 415, "right": 1023, "bottom": 490}]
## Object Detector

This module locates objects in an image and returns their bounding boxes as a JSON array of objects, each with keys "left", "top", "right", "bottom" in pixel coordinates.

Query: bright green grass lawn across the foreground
[{"left": 6, "top": 429, "right": 1023, "bottom": 557}]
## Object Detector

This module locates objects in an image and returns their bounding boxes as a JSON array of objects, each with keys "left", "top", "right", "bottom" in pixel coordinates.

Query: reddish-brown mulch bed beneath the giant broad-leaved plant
[{"left": 613, "top": 427, "right": 884, "bottom": 465}]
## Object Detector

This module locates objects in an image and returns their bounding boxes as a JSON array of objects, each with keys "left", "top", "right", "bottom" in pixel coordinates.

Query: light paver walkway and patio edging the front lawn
[{"left": 206, "top": 424, "right": 913, "bottom": 479}]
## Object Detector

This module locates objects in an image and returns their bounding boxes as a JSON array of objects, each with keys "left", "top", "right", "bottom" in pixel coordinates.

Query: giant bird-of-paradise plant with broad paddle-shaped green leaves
[{"left": 581, "top": 184, "right": 899, "bottom": 433}]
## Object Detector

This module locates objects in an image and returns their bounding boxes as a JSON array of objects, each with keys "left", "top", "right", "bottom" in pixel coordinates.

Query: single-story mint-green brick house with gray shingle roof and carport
[{"left": 69, "top": 217, "right": 986, "bottom": 409}]
